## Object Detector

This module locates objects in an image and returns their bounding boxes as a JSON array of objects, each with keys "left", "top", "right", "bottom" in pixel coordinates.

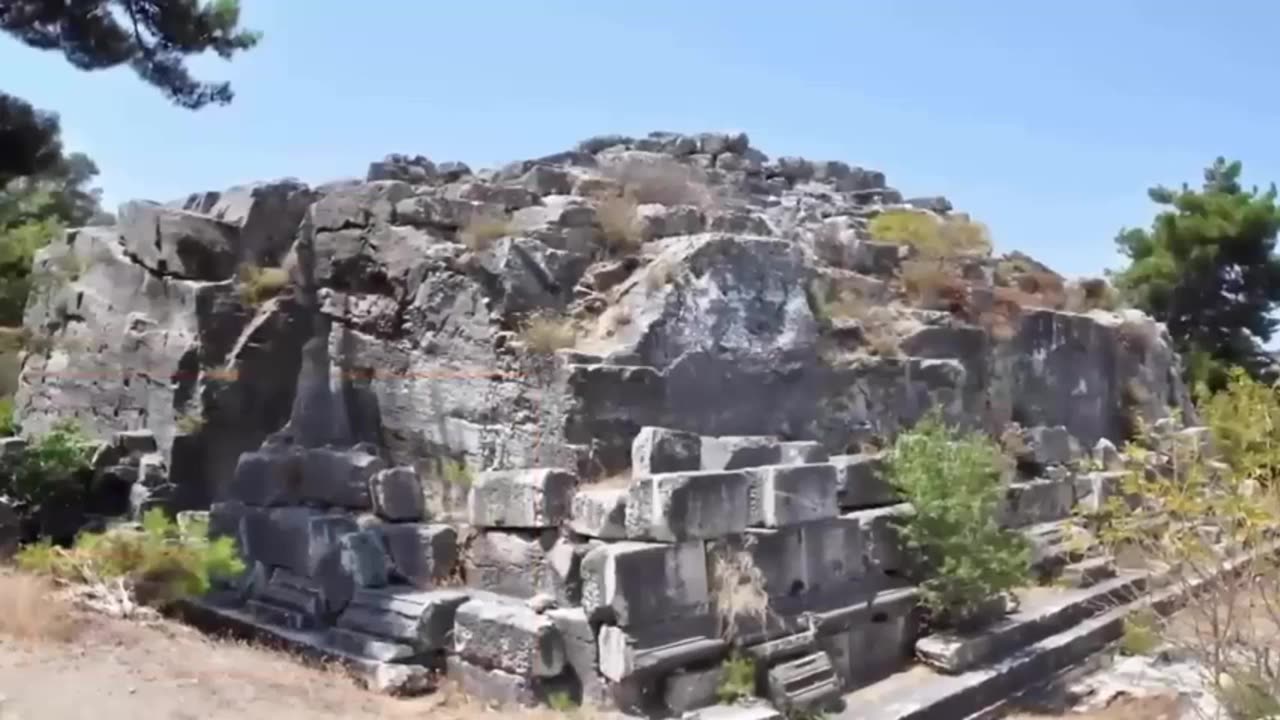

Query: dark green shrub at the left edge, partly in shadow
[{"left": 0, "top": 420, "right": 93, "bottom": 512}]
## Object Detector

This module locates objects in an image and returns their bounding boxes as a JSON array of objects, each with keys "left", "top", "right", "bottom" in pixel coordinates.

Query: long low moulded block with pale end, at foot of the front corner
[{"left": 596, "top": 615, "right": 728, "bottom": 683}]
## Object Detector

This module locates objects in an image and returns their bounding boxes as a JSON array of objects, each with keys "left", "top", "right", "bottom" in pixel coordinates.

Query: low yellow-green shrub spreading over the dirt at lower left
[{"left": 17, "top": 509, "right": 244, "bottom": 606}]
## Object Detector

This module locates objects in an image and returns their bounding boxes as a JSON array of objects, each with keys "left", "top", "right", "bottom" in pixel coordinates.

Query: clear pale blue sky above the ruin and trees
[{"left": 0, "top": 0, "right": 1280, "bottom": 274}]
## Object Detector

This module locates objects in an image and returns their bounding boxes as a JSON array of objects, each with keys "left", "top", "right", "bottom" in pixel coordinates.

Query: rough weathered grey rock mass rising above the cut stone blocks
[{"left": 10, "top": 133, "right": 1187, "bottom": 506}]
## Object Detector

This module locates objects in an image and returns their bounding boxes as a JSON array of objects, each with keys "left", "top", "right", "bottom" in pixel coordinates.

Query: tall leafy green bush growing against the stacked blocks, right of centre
[{"left": 888, "top": 413, "right": 1029, "bottom": 624}]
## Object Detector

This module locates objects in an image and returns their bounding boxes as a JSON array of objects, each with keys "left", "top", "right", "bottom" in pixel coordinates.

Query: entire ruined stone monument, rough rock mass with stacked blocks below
[{"left": 2, "top": 133, "right": 1190, "bottom": 716}]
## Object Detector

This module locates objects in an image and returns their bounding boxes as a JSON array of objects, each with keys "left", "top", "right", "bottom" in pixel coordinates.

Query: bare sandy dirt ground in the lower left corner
[{"left": 0, "top": 574, "right": 565, "bottom": 720}]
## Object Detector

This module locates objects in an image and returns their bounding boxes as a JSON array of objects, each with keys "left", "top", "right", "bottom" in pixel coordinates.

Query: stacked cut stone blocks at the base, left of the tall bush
[{"left": 211, "top": 428, "right": 914, "bottom": 714}]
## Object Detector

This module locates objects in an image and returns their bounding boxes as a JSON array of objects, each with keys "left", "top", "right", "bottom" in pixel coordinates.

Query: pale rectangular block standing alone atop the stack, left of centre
[{"left": 467, "top": 469, "right": 577, "bottom": 529}]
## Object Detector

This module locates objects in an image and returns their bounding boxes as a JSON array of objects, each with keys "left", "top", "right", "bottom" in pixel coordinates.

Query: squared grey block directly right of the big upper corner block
[{"left": 748, "top": 464, "right": 840, "bottom": 528}]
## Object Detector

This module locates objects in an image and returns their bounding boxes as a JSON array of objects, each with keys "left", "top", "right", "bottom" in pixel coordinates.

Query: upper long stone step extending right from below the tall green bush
[{"left": 915, "top": 566, "right": 1146, "bottom": 674}]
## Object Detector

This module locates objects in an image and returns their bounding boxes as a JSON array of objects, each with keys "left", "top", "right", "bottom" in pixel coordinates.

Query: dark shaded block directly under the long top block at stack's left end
[{"left": 243, "top": 507, "right": 360, "bottom": 578}]
